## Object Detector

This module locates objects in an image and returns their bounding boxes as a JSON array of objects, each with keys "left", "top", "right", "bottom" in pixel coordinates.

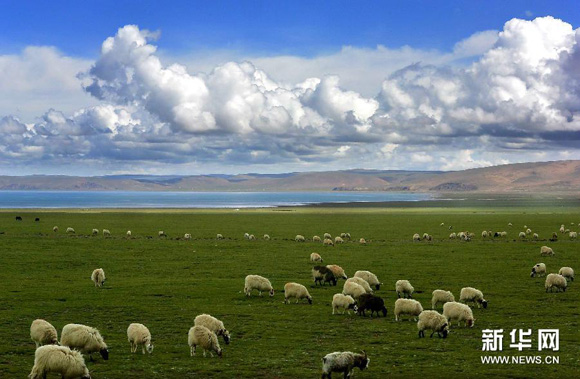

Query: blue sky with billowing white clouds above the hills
[{"left": 0, "top": 0, "right": 580, "bottom": 176}]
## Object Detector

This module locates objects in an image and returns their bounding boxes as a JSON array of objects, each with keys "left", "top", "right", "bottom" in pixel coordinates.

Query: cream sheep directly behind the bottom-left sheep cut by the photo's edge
[{"left": 60, "top": 324, "right": 109, "bottom": 361}]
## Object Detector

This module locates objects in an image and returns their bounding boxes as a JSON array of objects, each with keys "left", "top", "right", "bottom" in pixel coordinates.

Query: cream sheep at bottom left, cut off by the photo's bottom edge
[{"left": 28, "top": 345, "right": 91, "bottom": 379}]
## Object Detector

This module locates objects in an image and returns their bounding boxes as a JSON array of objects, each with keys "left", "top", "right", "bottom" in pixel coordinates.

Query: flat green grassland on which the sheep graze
[{"left": 0, "top": 208, "right": 580, "bottom": 378}]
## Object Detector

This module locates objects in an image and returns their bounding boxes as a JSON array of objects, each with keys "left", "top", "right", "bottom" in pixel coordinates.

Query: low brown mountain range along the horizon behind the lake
[{"left": 0, "top": 161, "right": 580, "bottom": 192}]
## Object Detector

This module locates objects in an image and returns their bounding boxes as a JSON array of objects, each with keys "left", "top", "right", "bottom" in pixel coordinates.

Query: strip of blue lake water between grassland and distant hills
[{"left": 0, "top": 191, "right": 431, "bottom": 208}]
